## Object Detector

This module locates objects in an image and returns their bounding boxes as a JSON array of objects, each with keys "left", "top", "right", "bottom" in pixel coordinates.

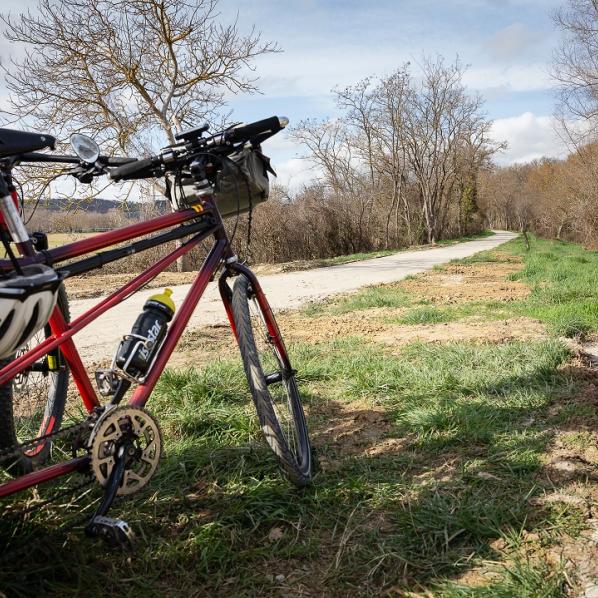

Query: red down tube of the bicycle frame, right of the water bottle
[{"left": 129, "top": 239, "right": 228, "bottom": 407}]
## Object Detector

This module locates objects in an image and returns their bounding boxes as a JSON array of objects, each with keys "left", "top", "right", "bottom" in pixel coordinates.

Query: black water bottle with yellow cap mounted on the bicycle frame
[{"left": 115, "top": 289, "right": 175, "bottom": 380}]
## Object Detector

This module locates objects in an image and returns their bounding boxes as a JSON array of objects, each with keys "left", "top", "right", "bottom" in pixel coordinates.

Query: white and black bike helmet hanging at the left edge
[{"left": 0, "top": 264, "right": 61, "bottom": 359}]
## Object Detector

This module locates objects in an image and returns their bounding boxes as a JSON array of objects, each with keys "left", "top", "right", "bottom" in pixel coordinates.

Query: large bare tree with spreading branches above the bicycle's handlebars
[{"left": 2, "top": 0, "right": 277, "bottom": 264}]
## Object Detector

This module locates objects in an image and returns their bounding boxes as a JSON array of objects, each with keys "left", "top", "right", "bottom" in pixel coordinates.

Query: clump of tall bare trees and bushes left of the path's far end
[{"left": 278, "top": 57, "right": 498, "bottom": 257}]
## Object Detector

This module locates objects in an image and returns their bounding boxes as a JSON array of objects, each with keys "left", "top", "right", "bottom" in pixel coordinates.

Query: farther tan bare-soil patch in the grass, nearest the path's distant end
[{"left": 400, "top": 260, "right": 530, "bottom": 304}]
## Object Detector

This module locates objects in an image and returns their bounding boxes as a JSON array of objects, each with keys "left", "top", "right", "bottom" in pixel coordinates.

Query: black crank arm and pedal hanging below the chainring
[{"left": 85, "top": 446, "right": 135, "bottom": 548}]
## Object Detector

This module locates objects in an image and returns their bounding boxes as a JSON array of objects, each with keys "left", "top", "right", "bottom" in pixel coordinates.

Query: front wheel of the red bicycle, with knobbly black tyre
[{"left": 232, "top": 275, "right": 313, "bottom": 487}]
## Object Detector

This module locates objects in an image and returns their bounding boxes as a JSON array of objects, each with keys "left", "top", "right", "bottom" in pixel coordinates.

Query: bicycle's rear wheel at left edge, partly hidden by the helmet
[{"left": 0, "top": 285, "right": 70, "bottom": 475}]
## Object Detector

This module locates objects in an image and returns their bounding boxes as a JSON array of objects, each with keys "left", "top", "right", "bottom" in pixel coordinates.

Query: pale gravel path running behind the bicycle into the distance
[{"left": 71, "top": 231, "right": 516, "bottom": 361}]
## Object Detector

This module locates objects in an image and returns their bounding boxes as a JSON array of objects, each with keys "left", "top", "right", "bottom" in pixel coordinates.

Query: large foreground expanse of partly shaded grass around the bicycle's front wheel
[{"left": 0, "top": 338, "right": 574, "bottom": 596}]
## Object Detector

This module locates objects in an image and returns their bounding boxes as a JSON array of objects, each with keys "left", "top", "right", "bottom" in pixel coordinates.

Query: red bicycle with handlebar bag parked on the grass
[{"left": 0, "top": 117, "right": 312, "bottom": 542}]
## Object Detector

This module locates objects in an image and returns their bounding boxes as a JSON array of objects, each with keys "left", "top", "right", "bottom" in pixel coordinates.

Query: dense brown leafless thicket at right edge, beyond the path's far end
[{"left": 479, "top": 143, "right": 598, "bottom": 247}]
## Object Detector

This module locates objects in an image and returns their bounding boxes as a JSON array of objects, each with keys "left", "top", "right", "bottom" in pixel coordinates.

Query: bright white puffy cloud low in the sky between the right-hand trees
[{"left": 492, "top": 112, "right": 567, "bottom": 164}]
